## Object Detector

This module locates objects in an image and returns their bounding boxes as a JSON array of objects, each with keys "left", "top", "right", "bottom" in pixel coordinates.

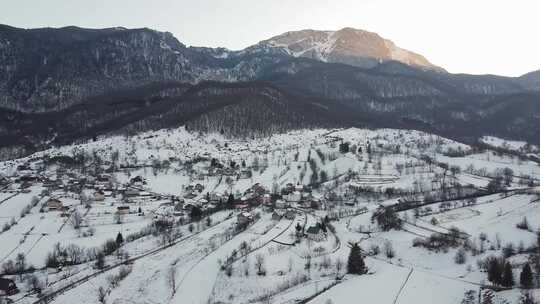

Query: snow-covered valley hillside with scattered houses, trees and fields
[{"left": 0, "top": 127, "right": 540, "bottom": 304}]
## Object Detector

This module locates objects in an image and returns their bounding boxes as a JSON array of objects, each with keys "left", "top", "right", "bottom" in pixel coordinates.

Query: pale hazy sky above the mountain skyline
[{"left": 0, "top": 0, "right": 540, "bottom": 76}]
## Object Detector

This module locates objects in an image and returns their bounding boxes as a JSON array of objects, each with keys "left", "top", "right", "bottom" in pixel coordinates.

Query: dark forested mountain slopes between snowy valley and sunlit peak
[{"left": 0, "top": 26, "right": 540, "bottom": 158}]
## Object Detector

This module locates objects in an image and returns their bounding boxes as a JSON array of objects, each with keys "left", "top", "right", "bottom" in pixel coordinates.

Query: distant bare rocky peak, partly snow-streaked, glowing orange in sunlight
[{"left": 250, "top": 27, "right": 443, "bottom": 71}]
